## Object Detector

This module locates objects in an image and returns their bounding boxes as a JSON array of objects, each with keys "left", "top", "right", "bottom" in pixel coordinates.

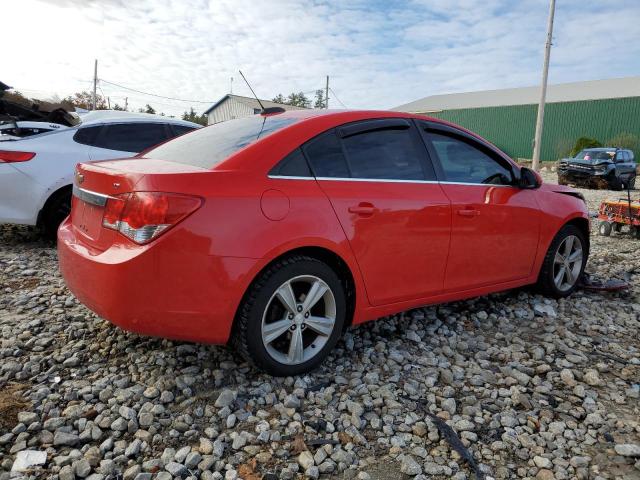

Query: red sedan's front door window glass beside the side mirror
[{"left": 428, "top": 132, "right": 513, "bottom": 185}]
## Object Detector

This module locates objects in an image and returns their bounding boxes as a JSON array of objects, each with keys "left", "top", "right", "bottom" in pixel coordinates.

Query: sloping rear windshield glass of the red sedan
[{"left": 144, "top": 115, "right": 297, "bottom": 168}]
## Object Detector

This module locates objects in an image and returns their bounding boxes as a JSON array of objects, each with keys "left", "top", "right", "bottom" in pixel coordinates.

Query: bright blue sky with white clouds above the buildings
[{"left": 5, "top": 0, "right": 640, "bottom": 115}]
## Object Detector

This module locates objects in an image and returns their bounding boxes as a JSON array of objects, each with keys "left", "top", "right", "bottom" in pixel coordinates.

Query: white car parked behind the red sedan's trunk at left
[{"left": 0, "top": 110, "right": 200, "bottom": 237}]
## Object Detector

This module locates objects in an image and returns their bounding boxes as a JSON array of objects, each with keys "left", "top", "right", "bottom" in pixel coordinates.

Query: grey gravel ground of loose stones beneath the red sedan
[{"left": 0, "top": 173, "right": 640, "bottom": 480}]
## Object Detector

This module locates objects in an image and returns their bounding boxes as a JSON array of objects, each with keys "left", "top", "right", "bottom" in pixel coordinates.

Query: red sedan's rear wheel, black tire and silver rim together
[{"left": 232, "top": 255, "right": 347, "bottom": 376}]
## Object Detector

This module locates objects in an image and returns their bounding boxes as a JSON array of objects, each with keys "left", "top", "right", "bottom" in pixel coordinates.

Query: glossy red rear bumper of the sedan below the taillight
[{"left": 58, "top": 218, "right": 258, "bottom": 344}]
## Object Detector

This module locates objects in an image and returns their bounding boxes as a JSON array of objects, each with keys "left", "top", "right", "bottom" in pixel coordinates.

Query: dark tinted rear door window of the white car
[{"left": 95, "top": 123, "right": 169, "bottom": 153}]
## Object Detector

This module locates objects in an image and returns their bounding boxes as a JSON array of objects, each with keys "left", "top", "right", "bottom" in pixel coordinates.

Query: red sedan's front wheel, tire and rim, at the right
[{"left": 536, "top": 225, "right": 589, "bottom": 298}]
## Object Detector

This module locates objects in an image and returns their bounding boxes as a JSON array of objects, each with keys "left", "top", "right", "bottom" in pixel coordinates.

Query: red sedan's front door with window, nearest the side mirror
[{"left": 419, "top": 122, "right": 540, "bottom": 291}]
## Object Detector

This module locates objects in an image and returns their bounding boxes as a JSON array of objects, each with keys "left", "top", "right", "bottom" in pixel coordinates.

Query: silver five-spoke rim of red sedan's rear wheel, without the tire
[{"left": 261, "top": 275, "right": 336, "bottom": 365}]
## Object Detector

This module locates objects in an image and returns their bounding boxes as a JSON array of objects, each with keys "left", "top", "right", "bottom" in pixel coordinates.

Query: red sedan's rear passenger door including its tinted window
[{"left": 303, "top": 118, "right": 451, "bottom": 305}]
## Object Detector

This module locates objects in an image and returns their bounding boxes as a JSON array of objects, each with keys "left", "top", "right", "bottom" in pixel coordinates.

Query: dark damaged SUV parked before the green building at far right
[{"left": 558, "top": 147, "right": 636, "bottom": 190}]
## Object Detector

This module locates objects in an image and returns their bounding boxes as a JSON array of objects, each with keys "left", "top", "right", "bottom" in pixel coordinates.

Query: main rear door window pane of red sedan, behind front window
[{"left": 342, "top": 128, "right": 425, "bottom": 180}]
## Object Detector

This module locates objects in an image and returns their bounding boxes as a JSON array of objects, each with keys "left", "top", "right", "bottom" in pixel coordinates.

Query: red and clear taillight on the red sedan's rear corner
[{"left": 102, "top": 192, "right": 202, "bottom": 245}]
